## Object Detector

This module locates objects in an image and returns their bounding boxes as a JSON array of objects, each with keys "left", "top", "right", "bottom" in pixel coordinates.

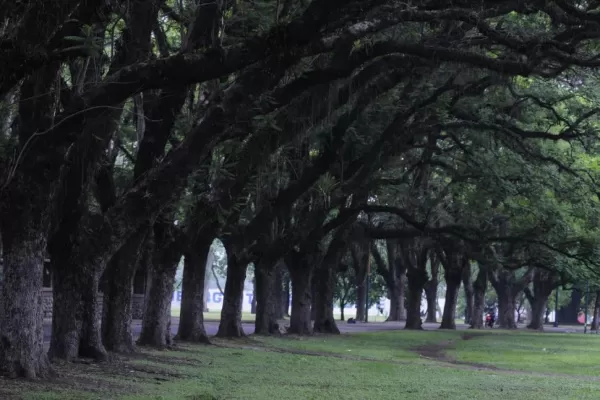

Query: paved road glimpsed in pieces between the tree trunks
[{"left": 44, "top": 318, "right": 596, "bottom": 342}]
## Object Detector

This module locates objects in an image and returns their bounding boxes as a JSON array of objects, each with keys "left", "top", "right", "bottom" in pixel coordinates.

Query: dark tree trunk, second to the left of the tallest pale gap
[{"left": 137, "top": 223, "right": 182, "bottom": 349}]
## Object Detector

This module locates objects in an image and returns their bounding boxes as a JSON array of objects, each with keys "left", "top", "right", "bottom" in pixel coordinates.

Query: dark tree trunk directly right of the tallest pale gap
[{"left": 217, "top": 250, "right": 247, "bottom": 338}]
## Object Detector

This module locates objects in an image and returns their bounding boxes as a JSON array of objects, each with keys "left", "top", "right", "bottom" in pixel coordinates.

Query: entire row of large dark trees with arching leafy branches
[{"left": 0, "top": 0, "right": 600, "bottom": 377}]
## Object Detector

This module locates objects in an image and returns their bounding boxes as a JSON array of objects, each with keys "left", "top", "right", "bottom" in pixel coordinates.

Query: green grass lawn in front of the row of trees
[{"left": 0, "top": 330, "right": 600, "bottom": 400}]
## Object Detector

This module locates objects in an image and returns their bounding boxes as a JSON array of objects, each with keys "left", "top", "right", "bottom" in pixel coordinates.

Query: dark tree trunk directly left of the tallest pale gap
[{"left": 177, "top": 239, "right": 212, "bottom": 343}]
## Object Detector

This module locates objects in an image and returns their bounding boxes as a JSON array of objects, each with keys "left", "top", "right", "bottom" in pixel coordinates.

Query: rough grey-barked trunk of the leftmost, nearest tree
[{"left": 0, "top": 58, "right": 64, "bottom": 378}]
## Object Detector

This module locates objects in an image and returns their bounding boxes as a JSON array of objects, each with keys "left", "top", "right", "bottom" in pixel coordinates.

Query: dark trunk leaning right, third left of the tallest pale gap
[{"left": 102, "top": 228, "right": 147, "bottom": 353}]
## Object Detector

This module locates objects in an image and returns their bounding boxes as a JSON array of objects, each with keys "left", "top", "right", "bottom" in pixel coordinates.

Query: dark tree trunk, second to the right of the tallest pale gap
[{"left": 254, "top": 261, "right": 279, "bottom": 335}]
